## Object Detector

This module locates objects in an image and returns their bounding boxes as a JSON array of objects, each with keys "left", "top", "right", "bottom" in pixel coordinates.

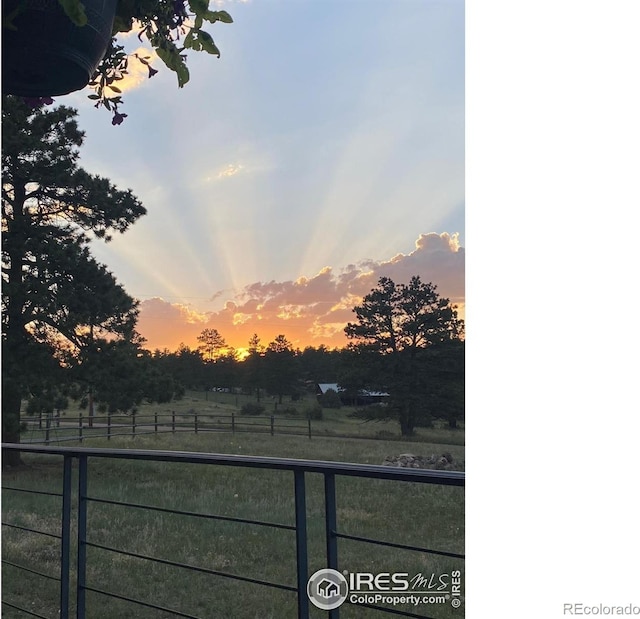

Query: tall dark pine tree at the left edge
[{"left": 2, "top": 96, "right": 145, "bottom": 464}]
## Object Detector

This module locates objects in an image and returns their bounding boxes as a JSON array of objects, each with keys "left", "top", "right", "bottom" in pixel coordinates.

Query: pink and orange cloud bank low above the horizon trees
[{"left": 139, "top": 232, "right": 464, "bottom": 350}]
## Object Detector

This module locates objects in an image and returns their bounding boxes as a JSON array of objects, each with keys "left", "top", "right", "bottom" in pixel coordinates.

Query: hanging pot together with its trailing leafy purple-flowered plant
[{"left": 2, "top": 0, "right": 233, "bottom": 125}]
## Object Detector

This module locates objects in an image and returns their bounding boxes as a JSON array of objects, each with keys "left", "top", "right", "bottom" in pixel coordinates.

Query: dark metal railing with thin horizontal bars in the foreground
[{"left": 2, "top": 443, "right": 465, "bottom": 619}]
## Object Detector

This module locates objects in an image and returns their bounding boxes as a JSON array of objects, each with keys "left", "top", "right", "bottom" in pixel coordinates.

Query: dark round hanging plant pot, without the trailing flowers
[{"left": 2, "top": 0, "right": 117, "bottom": 97}]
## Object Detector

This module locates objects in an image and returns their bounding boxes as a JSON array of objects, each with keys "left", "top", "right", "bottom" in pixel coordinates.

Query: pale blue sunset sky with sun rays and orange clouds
[{"left": 56, "top": 0, "right": 465, "bottom": 350}]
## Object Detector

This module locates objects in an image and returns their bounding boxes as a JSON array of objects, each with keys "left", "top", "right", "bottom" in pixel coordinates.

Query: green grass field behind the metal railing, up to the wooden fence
[{"left": 3, "top": 410, "right": 464, "bottom": 619}]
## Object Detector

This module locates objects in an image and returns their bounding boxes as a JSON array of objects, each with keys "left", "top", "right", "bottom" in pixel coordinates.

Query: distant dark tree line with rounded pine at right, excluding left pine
[{"left": 153, "top": 276, "right": 464, "bottom": 436}]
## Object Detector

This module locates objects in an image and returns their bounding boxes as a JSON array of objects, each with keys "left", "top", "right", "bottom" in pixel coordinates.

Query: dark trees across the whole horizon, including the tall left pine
[{"left": 2, "top": 96, "right": 464, "bottom": 464}]
